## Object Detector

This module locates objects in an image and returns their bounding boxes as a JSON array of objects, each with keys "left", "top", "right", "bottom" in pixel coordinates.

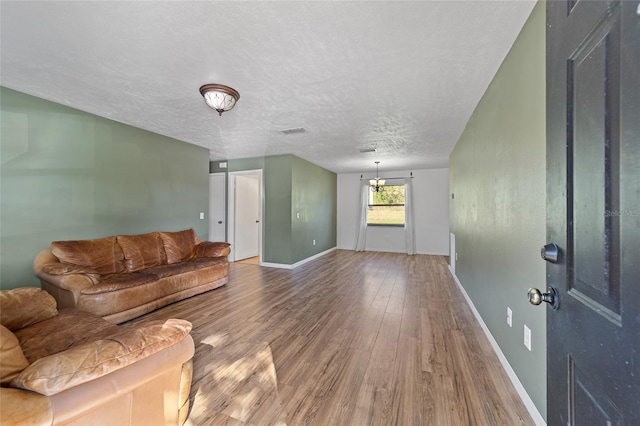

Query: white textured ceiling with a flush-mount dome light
[{"left": 0, "top": 0, "right": 535, "bottom": 175}]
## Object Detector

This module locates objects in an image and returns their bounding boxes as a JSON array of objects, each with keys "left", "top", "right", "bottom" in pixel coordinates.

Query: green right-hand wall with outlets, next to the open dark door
[{"left": 450, "top": 2, "right": 546, "bottom": 417}]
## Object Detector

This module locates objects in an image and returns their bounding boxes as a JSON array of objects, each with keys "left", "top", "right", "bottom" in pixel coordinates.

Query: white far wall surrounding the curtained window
[{"left": 337, "top": 169, "right": 449, "bottom": 255}]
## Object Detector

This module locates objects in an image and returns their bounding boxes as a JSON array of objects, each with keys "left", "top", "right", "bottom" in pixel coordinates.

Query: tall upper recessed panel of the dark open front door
[{"left": 567, "top": 5, "right": 620, "bottom": 316}]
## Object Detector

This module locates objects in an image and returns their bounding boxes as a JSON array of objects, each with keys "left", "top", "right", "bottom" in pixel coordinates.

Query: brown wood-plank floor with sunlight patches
[{"left": 134, "top": 250, "right": 533, "bottom": 426}]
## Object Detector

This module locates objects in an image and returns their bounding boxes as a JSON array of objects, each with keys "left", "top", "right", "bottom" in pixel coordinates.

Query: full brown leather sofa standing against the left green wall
[{"left": 33, "top": 229, "right": 229, "bottom": 323}]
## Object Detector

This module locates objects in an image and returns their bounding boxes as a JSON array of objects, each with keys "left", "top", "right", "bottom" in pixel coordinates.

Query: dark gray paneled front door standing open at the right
[{"left": 547, "top": 0, "right": 640, "bottom": 426}]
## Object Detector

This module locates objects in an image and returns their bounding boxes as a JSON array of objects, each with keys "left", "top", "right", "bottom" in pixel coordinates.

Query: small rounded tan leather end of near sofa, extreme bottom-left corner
[{"left": 0, "top": 388, "right": 53, "bottom": 426}]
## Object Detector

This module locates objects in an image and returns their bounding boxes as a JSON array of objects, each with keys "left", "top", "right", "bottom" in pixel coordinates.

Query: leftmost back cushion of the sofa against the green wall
[{"left": 51, "top": 236, "right": 125, "bottom": 274}]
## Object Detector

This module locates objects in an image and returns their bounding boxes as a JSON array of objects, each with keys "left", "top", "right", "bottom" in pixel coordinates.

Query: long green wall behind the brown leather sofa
[{"left": 0, "top": 88, "right": 209, "bottom": 289}]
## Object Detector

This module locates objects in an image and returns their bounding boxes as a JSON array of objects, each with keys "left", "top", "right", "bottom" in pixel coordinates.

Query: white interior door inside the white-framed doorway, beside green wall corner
[{"left": 234, "top": 175, "right": 260, "bottom": 260}]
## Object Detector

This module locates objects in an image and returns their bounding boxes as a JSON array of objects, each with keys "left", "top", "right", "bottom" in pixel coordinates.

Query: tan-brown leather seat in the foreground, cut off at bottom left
[{"left": 0, "top": 287, "right": 194, "bottom": 425}]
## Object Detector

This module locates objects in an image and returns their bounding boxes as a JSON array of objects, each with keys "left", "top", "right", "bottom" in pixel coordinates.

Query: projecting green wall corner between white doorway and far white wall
[{"left": 228, "top": 154, "right": 337, "bottom": 265}]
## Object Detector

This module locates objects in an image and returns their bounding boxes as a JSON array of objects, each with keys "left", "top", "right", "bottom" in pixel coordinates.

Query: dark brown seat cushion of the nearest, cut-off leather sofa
[{"left": 15, "top": 309, "right": 118, "bottom": 362}]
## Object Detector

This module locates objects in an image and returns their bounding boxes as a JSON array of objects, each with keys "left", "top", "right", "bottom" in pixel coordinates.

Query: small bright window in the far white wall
[{"left": 367, "top": 185, "right": 404, "bottom": 226}]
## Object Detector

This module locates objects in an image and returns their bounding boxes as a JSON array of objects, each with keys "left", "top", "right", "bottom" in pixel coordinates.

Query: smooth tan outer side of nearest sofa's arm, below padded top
[{"left": 0, "top": 335, "right": 195, "bottom": 426}]
